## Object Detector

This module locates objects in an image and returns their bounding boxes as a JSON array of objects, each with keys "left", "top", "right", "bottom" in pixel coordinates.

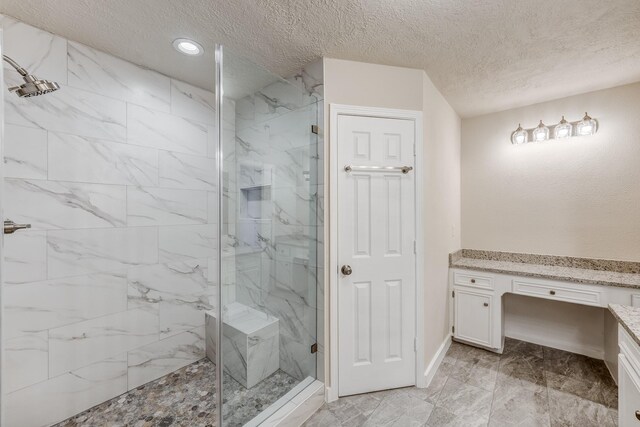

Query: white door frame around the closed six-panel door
[{"left": 325, "top": 103, "right": 425, "bottom": 402}]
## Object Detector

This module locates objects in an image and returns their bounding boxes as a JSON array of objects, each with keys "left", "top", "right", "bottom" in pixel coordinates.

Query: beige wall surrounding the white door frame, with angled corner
[{"left": 324, "top": 58, "right": 460, "bottom": 383}]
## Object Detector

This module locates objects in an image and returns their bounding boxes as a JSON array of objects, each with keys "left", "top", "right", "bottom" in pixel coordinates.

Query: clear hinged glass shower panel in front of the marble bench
[{"left": 221, "top": 49, "right": 319, "bottom": 426}]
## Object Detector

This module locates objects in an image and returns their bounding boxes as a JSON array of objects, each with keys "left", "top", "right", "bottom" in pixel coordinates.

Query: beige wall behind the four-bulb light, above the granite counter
[{"left": 462, "top": 83, "right": 640, "bottom": 261}]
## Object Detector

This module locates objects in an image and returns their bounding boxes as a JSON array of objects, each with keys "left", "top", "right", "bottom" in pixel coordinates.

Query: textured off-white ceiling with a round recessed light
[{"left": 0, "top": 0, "right": 640, "bottom": 117}]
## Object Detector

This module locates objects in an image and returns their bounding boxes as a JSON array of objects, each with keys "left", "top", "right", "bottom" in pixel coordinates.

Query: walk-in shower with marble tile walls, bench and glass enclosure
[{"left": 0, "top": 11, "right": 324, "bottom": 427}]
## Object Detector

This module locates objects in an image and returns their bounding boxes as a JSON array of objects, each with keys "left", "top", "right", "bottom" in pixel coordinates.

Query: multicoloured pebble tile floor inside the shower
[{"left": 55, "top": 359, "right": 299, "bottom": 427}]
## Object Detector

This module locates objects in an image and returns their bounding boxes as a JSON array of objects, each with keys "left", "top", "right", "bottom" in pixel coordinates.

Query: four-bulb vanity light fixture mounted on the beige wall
[{"left": 511, "top": 113, "right": 598, "bottom": 145}]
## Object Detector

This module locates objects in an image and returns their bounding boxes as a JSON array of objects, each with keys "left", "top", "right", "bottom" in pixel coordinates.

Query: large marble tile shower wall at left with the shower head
[{"left": 0, "top": 15, "right": 233, "bottom": 426}]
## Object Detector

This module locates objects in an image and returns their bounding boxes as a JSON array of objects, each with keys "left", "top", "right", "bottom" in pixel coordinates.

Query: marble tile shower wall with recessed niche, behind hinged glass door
[{"left": 235, "top": 61, "right": 324, "bottom": 380}]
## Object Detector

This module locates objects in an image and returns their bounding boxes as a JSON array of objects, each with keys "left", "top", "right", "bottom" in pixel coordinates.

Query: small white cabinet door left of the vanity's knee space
[{"left": 454, "top": 288, "right": 493, "bottom": 347}]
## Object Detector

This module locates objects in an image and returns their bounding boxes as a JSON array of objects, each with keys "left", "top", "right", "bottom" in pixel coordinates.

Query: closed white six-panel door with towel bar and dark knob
[{"left": 337, "top": 115, "right": 416, "bottom": 396}]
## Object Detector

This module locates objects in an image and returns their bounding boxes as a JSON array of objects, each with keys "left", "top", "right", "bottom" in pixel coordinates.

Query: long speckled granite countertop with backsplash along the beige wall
[{"left": 449, "top": 249, "right": 640, "bottom": 289}]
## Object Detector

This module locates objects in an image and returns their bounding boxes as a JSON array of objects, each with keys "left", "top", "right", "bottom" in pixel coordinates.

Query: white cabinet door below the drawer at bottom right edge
[{"left": 618, "top": 354, "right": 640, "bottom": 427}]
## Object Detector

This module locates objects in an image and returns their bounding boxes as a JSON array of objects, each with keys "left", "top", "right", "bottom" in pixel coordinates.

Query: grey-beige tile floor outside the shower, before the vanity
[{"left": 305, "top": 339, "right": 618, "bottom": 427}]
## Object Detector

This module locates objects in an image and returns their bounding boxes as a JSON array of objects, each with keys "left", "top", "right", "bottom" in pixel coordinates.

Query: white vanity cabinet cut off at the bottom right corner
[{"left": 618, "top": 326, "right": 640, "bottom": 427}]
